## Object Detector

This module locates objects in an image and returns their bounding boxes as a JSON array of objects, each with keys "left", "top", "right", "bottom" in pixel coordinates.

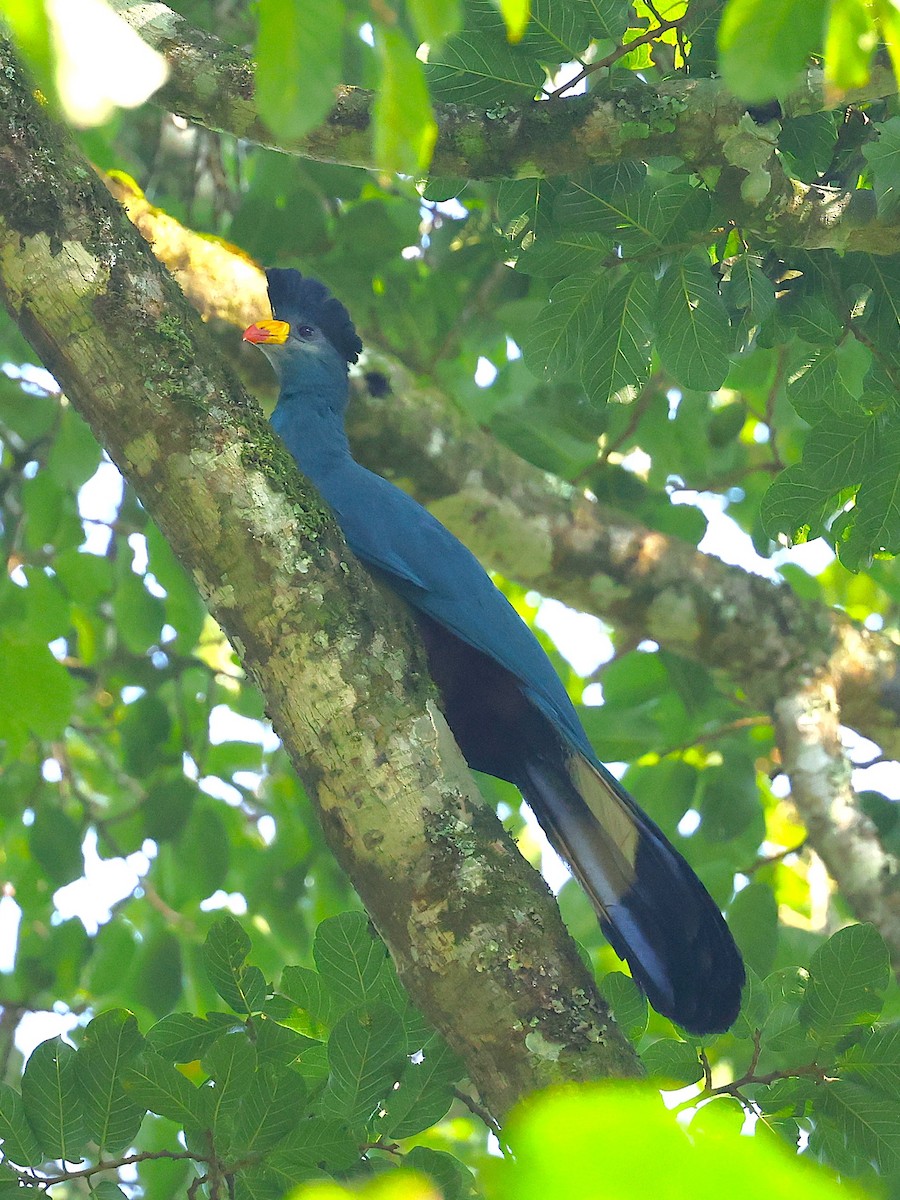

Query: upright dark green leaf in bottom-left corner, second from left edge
[{"left": 22, "top": 1038, "right": 88, "bottom": 1163}]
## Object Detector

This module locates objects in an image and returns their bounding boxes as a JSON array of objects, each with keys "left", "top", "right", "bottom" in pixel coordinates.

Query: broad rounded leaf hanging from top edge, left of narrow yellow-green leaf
[{"left": 256, "top": 0, "right": 344, "bottom": 138}]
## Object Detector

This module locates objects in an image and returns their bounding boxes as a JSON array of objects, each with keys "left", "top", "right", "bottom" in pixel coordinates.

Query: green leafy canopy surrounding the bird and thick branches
[{"left": 0, "top": 0, "right": 900, "bottom": 1200}]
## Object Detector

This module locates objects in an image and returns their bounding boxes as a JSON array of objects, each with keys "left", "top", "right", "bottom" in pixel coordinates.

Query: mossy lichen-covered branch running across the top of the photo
[{"left": 113, "top": 0, "right": 900, "bottom": 254}]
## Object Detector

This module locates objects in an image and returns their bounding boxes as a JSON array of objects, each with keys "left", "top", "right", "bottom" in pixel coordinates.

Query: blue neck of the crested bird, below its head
[{"left": 272, "top": 371, "right": 353, "bottom": 482}]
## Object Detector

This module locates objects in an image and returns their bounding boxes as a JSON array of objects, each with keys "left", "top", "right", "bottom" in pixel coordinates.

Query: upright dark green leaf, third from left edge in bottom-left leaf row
[{"left": 76, "top": 1008, "right": 146, "bottom": 1154}]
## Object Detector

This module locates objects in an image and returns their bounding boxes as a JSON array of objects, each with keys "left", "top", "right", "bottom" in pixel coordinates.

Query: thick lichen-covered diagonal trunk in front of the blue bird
[{"left": 0, "top": 41, "right": 638, "bottom": 1115}]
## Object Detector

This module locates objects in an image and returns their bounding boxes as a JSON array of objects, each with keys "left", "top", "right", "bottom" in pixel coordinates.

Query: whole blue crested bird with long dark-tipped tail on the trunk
[{"left": 244, "top": 269, "right": 744, "bottom": 1034}]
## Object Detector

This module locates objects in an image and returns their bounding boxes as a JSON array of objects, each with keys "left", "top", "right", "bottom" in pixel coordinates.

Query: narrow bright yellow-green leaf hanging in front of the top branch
[{"left": 373, "top": 26, "right": 438, "bottom": 175}]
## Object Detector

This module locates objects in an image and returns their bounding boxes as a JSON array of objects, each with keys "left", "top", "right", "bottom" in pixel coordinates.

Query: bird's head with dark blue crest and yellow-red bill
[{"left": 244, "top": 268, "right": 362, "bottom": 389}]
